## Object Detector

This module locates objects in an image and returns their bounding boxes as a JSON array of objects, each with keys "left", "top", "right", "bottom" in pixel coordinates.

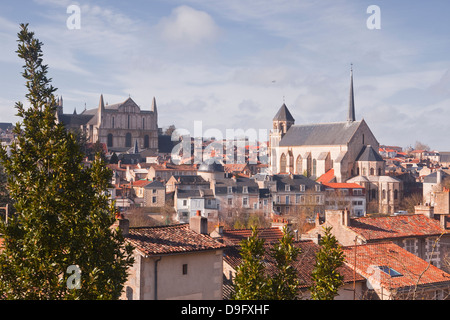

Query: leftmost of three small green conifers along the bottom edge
[{"left": 232, "top": 227, "right": 267, "bottom": 300}]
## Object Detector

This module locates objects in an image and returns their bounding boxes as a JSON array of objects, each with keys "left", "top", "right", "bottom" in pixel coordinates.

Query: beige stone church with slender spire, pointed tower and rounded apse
[{"left": 269, "top": 70, "right": 402, "bottom": 213}]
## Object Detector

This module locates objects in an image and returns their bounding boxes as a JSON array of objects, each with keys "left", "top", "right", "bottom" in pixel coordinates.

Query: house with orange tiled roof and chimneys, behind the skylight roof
[{"left": 306, "top": 210, "right": 450, "bottom": 271}]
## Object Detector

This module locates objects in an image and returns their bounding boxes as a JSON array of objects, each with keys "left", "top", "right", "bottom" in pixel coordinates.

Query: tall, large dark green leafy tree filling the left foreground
[{"left": 0, "top": 24, "right": 134, "bottom": 300}]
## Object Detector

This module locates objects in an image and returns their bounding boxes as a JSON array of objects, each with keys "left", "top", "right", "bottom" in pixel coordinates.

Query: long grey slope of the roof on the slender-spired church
[{"left": 279, "top": 121, "right": 362, "bottom": 147}]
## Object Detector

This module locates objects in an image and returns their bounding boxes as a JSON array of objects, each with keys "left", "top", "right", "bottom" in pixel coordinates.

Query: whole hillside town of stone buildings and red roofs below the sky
[{"left": 0, "top": 67, "right": 450, "bottom": 300}]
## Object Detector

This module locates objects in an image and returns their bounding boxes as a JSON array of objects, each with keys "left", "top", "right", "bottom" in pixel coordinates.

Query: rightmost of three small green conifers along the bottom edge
[{"left": 310, "top": 227, "right": 344, "bottom": 300}]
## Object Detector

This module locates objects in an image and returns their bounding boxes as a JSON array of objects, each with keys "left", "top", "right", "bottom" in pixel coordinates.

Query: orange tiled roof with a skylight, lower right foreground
[{"left": 343, "top": 242, "right": 450, "bottom": 289}]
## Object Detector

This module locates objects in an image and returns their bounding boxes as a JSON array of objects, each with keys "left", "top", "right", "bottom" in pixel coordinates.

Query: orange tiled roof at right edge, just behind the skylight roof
[{"left": 349, "top": 214, "right": 450, "bottom": 240}]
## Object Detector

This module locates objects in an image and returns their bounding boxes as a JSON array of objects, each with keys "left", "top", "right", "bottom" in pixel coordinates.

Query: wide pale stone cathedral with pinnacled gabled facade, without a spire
[{"left": 56, "top": 95, "right": 158, "bottom": 152}]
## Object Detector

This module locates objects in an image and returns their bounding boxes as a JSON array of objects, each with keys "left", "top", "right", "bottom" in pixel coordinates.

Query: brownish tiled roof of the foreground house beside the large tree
[{"left": 125, "top": 224, "right": 226, "bottom": 255}]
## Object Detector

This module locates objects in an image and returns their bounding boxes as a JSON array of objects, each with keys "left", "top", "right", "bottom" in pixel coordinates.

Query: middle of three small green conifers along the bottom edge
[{"left": 268, "top": 227, "right": 301, "bottom": 300}]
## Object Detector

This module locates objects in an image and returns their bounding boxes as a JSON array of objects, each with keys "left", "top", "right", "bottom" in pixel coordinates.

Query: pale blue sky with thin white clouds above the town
[{"left": 0, "top": 0, "right": 450, "bottom": 151}]
